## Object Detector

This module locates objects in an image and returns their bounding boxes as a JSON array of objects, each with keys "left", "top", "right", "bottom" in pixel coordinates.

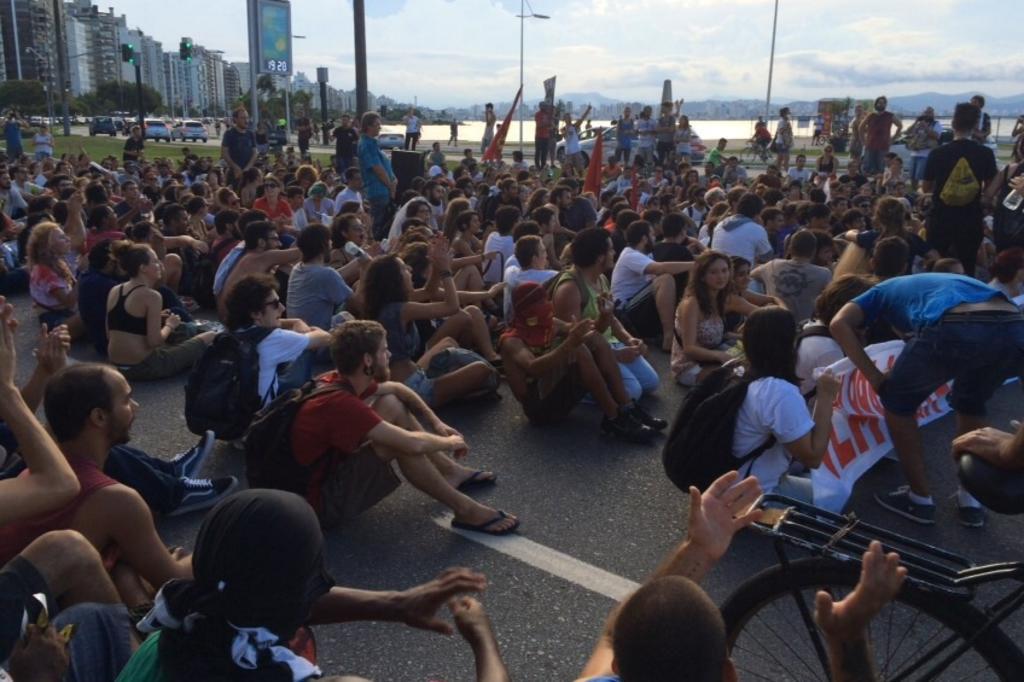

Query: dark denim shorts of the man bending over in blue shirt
[{"left": 879, "top": 311, "right": 1024, "bottom": 417}]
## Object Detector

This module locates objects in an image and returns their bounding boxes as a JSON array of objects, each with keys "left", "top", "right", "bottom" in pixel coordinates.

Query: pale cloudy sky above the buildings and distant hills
[{"left": 98, "top": 0, "right": 1024, "bottom": 108}]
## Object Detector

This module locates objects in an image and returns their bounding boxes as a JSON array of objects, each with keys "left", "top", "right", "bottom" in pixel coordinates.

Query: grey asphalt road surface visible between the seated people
[{"left": 8, "top": 288, "right": 1024, "bottom": 682}]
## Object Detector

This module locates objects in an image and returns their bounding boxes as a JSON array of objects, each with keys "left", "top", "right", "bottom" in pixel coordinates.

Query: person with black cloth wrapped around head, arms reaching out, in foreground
[{"left": 118, "top": 489, "right": 507, "bottom": 682}]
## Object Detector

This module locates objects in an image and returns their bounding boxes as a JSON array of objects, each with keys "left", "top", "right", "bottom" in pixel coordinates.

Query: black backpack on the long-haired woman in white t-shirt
[{"left": 662, "top": 367, "right": 775, "bottom": 493}]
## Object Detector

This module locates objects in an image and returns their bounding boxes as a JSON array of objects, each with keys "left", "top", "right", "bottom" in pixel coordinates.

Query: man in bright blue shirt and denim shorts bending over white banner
[{"left": 829, "top": 273, "right": 1024, "bottom": 527}]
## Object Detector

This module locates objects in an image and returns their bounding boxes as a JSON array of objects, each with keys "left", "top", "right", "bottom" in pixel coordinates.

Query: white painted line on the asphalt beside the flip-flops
[{"left": 432, "top": 512, "right": 640, "bottom": 601}]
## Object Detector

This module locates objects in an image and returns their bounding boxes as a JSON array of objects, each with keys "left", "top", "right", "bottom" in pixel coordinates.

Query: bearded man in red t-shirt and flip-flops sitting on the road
[{"left": 292, "top": 321, "right": 519, "bottom": 535}]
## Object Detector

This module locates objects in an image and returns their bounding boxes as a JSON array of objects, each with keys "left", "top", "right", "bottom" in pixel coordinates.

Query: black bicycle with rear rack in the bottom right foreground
[{"left": 722, "top": 477, "right": 1024, "bottom": 682}]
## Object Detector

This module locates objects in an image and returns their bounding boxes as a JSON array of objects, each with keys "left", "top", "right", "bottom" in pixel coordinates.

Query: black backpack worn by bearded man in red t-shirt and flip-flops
[{"left": 245, "top": 380, "right": 345, "bottom": 497}]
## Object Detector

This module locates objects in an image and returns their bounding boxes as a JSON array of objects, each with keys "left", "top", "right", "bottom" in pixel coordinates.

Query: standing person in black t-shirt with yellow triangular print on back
[{"left": 922, "top": 102, "right": 998, "bottom": 275}]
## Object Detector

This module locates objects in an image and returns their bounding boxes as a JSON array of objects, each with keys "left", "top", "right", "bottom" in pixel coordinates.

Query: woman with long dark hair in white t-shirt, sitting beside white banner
[{"left": 732, "top": 305, "right": 841, "bottom": 502}]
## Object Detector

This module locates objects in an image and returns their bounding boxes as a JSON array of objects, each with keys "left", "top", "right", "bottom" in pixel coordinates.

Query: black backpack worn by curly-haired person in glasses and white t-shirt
[{"left": 185, "top": 327, "right": 273, "bottom": 440}]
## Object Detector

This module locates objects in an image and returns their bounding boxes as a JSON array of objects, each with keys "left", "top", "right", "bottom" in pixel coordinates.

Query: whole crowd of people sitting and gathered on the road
[{"left": 0, "top": 97, "right": 1024, "bottom": 682}]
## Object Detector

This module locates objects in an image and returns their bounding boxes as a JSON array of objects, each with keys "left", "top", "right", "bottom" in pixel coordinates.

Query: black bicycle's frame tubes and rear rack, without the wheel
[{"left": 753, "top": 494, "right": 1024, "bottom": 680}]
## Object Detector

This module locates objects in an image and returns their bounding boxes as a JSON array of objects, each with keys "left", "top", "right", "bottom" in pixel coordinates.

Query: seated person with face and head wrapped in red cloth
[{"left": 499, "top": 282, "right": 654, "bottom": 443}]
